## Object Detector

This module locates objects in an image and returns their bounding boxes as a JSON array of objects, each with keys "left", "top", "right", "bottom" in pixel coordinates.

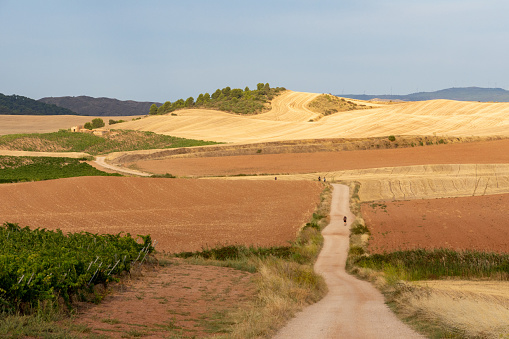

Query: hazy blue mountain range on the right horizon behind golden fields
[{"left": 338, "top": 87, "right": 509, "bottom": 102}]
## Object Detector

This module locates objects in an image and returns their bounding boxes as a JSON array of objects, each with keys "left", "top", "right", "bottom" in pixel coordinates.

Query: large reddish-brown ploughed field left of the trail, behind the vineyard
[{"left": 0, "top": 177, "right": 323, "bottom": 252}]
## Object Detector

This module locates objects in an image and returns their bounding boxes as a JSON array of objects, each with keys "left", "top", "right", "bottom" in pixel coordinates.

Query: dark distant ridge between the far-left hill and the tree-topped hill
[{"left": 38, "top": 96, "right": 162, "bottom": 116}]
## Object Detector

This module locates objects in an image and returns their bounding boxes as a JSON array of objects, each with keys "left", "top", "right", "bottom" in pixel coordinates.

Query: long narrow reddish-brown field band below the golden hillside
[{"left": 135, "top": 139, "right": 509, "bottom": 176}]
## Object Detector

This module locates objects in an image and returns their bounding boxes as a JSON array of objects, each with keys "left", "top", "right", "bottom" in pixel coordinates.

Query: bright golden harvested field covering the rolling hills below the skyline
[{"left": 113, "top": 91, "right": 509, "bottom": 142}]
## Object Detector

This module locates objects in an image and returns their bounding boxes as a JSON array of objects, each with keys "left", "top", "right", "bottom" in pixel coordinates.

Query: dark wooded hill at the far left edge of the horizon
[{"left": 0, "top": 93, "right": 76, "bottom": 115}]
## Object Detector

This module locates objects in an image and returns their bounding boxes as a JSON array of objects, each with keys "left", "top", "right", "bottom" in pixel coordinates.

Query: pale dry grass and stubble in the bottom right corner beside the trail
[{"left": 351, "top": 268, "right": 509, "bottom": 339}]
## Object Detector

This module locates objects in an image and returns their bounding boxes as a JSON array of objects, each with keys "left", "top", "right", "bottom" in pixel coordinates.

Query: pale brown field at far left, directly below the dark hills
[{"left": 0, "top": 115, "right": 140, "bottom": 135}]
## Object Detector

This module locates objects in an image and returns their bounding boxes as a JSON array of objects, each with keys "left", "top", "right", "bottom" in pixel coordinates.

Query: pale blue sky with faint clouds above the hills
[{"left": 0, "top": 0, "right": 509, "bottom": 102}]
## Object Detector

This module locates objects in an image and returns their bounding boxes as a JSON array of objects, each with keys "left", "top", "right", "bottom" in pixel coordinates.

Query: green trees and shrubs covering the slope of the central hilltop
[{"left": 149, "top": 83, "right": 285, "bottom": 115}]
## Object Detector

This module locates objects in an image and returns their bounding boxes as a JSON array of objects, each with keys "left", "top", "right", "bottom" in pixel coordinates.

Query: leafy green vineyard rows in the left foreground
[{"left": 0, "top": 223, "right": 154, "bottom": 313}]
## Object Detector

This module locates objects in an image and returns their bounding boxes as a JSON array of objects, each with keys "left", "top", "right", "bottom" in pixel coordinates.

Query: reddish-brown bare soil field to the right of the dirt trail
[{"left": 361, "top": 194, "right": 509, "bottom": 253}]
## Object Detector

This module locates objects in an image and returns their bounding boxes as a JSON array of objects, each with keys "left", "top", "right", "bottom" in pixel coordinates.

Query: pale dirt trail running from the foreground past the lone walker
[{"left": 275, "top": 184, "right": 424, "bottom": 339}]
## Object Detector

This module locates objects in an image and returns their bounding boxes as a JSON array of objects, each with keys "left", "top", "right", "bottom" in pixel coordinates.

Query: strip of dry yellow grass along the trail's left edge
[{"left": 220, "top": 188, "right": 332, "bottom": 338}]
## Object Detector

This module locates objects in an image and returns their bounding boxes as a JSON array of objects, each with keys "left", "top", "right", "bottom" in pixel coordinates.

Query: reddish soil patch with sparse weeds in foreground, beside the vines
[{"left": 75, "top": 264, "right": 256, "bottom": 338}]
